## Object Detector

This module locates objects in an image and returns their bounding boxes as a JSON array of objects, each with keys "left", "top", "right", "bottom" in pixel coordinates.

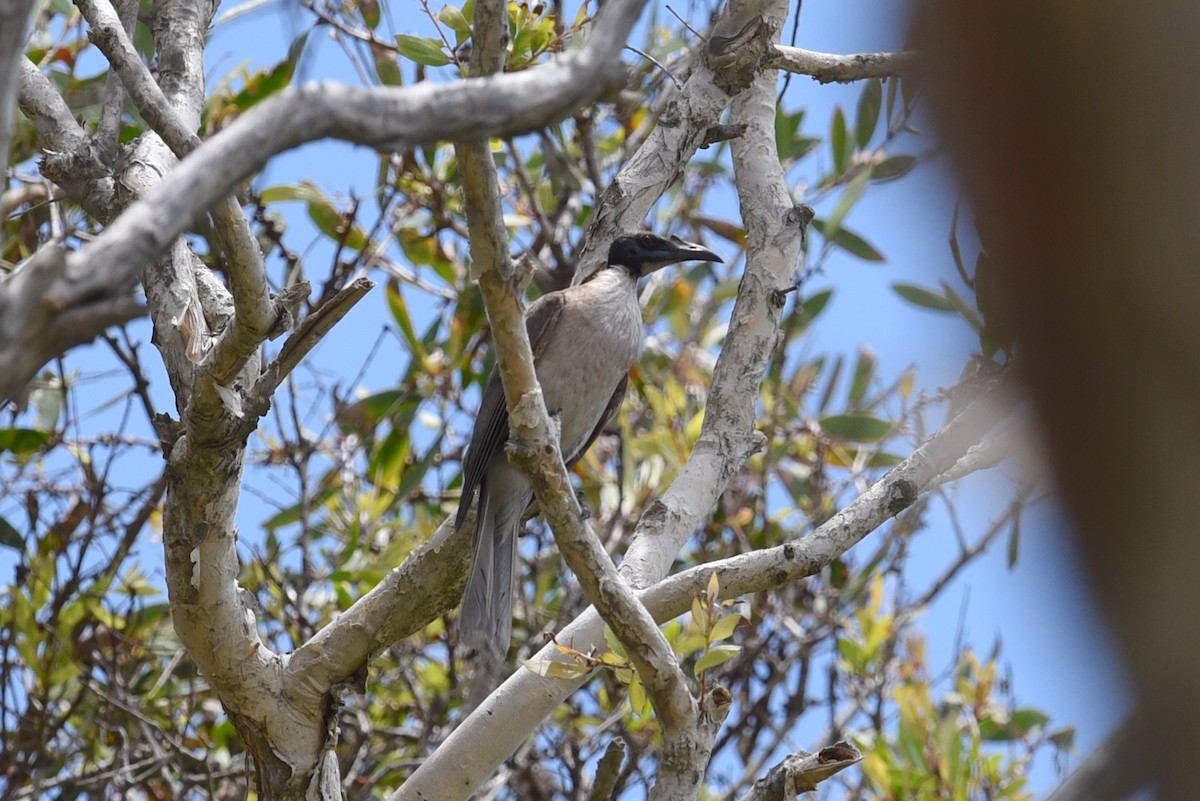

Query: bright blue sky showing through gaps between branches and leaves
[{"left": 0, "top": 0, "right": 1129, "bottom": 791}]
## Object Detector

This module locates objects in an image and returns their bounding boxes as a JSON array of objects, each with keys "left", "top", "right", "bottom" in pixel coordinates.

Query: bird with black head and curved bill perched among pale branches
[{"left": 455, "top": 231, "right": 724, "bottom": 655}]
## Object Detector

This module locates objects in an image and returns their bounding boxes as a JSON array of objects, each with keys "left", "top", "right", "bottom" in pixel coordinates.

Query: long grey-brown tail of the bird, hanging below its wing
[{"left": 458, "top": 484, "right": 524, "bottom": 656}]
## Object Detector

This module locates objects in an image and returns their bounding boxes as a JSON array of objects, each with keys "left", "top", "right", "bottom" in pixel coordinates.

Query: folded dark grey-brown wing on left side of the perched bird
[{"left": 455, "top": 293, "right": 566, "bottom": 528}]
